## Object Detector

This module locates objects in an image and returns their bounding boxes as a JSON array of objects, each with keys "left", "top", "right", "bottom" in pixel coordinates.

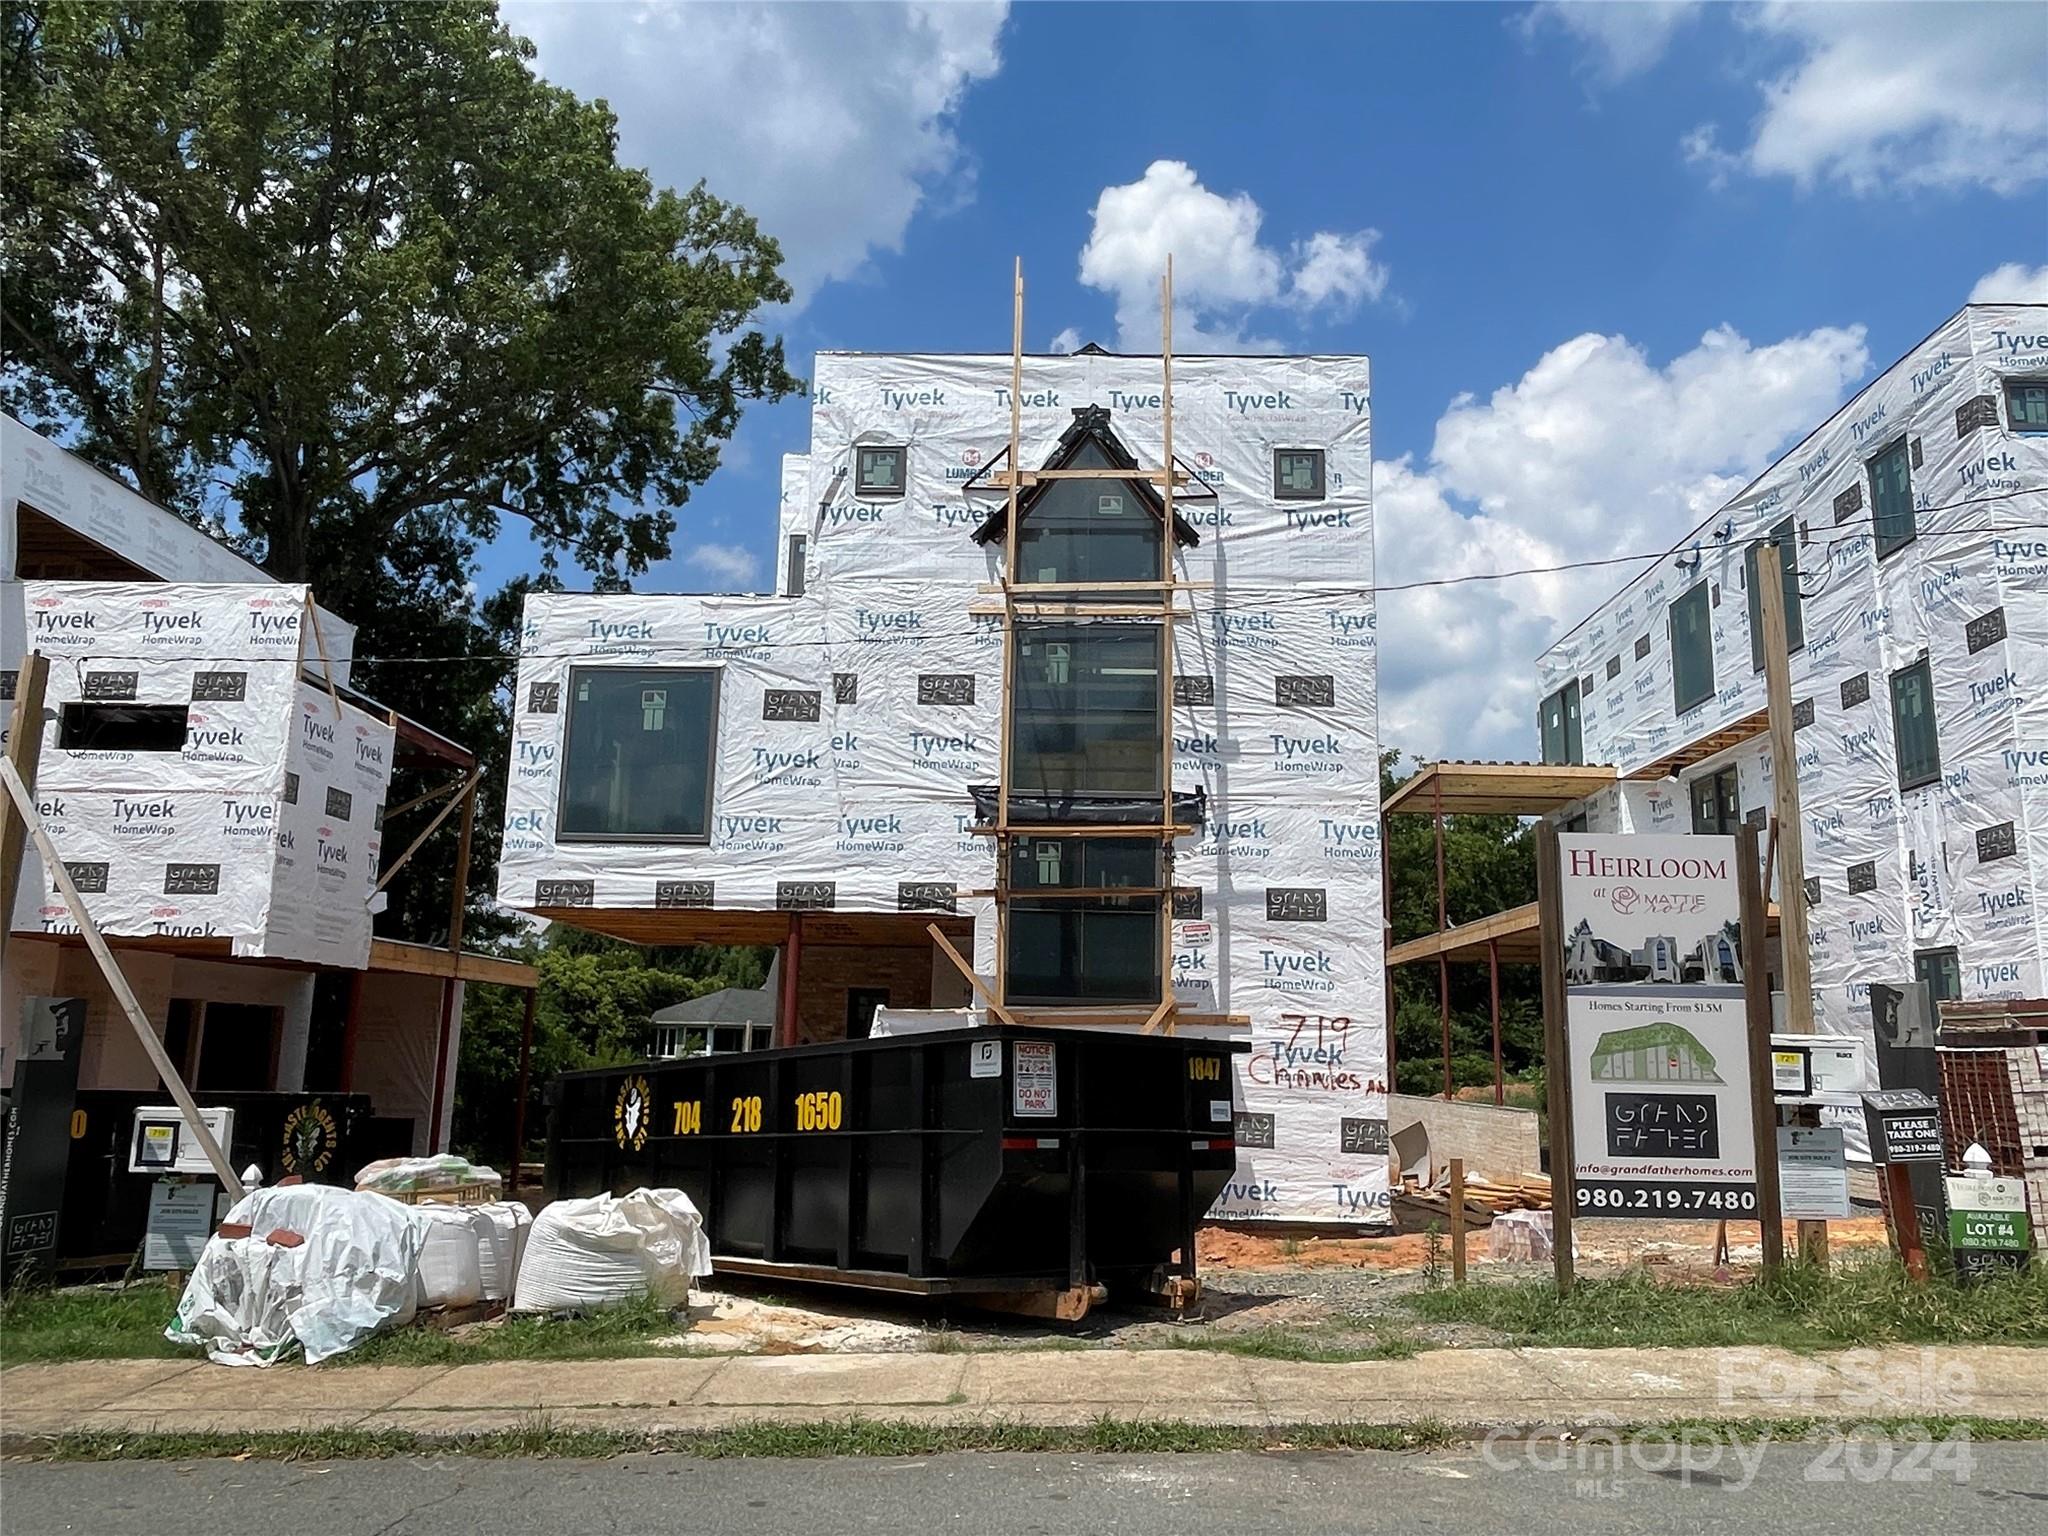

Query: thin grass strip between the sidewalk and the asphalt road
[{"left": 10, "top": 1415, "right": 2048, "bottom": 1462}]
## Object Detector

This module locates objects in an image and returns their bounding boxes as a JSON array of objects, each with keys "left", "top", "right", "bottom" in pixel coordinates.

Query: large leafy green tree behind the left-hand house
[{"left": 0, "top": 0, "right": 801, "bottom": 930}]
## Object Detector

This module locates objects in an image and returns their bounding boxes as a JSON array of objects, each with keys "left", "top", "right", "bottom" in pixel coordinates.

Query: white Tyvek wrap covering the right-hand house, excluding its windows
[{"left": 1538, "top": 305, "right": 2048, "bottom": 1139}]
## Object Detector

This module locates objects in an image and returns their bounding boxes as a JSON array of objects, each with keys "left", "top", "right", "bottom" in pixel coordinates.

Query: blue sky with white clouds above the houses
[{"left": 499, "top": 0, "right": 2048, "bottom": 756}]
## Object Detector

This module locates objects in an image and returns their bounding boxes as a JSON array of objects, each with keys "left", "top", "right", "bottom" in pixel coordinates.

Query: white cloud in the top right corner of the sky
[{"left": 1683, "top": 2, "right": 2048, "bottom": 195}]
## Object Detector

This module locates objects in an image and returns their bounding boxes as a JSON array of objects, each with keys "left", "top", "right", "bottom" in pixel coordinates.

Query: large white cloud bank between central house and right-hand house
[{"left": 1372, "top": 326, "right": 1870, "bottom": 758}]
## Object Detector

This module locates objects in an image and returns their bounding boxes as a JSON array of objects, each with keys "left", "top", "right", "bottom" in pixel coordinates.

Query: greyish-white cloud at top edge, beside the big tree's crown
[{"left": 504, "top": 0, "right": 1008, "bottom": 305}]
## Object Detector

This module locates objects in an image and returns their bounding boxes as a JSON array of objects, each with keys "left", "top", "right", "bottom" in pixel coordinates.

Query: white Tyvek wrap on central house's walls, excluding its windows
[{"left": 500, "top": 354, "right": 1386, "bottom": 1221}]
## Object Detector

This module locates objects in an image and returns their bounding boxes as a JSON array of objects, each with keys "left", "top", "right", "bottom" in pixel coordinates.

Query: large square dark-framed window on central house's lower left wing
[{"left": 557, "top": 668, "right": 719, "bottom": 842}]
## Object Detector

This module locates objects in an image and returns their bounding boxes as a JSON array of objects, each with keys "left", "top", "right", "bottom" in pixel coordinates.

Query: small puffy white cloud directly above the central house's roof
[{"left": 1081, "top": 160, "right": 1386, "bottom": 352}]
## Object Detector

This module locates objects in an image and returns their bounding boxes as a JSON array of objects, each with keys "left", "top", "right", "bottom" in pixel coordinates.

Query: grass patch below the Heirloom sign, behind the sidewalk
[{"left": 1401, "top": 1253, "right": 2048, "bottom": 1350}]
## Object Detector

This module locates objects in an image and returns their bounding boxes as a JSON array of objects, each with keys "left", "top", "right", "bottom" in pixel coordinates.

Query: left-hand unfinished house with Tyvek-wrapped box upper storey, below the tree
[{"left": 0, "top": 416, "right": 532, "bottom": 1178}]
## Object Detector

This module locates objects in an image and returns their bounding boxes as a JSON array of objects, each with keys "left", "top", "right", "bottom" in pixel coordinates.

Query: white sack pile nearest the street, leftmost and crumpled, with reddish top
[{"left": 164, "top": 1184, "right": 428, "bottom": 1366}]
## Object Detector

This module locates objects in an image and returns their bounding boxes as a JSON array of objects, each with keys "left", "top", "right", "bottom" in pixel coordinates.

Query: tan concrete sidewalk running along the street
[{"left": 0, "top": 1346, "right": 2048, "bottom": 1442}]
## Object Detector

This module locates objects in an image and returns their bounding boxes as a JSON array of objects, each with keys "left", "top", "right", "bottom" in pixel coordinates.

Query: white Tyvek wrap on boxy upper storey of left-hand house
[{"left": 8, "top": 582, "right": 393, "bottom": 967}]
